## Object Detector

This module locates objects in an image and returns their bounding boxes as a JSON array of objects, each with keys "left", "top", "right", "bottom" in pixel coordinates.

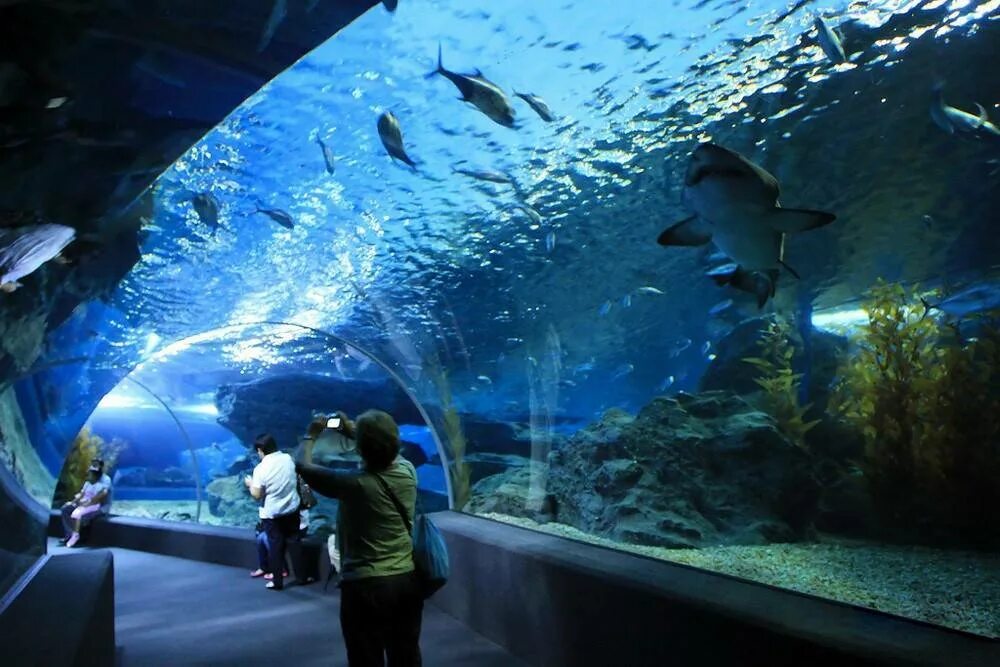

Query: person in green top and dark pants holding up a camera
[{"left": 296, "top": 410, "right": 424, "bottom": 667}]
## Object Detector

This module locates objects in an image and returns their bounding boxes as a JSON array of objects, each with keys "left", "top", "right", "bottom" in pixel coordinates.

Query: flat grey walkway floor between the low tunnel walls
[{"left": 49, "top": 540, "right": 526, "bottom": 667}]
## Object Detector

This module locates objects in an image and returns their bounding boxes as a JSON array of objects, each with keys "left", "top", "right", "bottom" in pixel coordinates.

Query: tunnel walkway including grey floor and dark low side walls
[{"left": 0, "top": 511, "right": 1000, "bottom": 667}]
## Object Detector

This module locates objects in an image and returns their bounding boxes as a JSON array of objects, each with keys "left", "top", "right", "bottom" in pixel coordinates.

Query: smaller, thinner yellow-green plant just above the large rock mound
[{"left": 743, "top": 320, "right": 819, "bottom": 447}]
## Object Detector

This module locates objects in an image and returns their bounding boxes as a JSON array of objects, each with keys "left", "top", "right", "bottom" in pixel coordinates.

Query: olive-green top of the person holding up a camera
[{"left": 296, "top": 458, "right": 417, "bottom": 581}]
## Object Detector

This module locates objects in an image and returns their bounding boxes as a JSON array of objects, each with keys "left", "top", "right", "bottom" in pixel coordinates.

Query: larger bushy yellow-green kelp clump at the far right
[{"left": 834, "top": 282, "right": 1000, "bottom": 546}]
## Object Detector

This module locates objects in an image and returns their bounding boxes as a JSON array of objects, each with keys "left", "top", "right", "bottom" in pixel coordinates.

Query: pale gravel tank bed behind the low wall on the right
[{"left": 481, "top": 513, "right": 1000, "bottom": 637}]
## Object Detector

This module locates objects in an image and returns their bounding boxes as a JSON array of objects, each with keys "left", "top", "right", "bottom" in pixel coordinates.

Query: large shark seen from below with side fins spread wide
[{"left": 658, "top": 143, "right": 836, "bottom": 306}]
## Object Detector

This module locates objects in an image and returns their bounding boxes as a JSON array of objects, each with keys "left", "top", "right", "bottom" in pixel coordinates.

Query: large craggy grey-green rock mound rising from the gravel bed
[{"left": 470, "top": 392, "right": 819, "bottom": 547}]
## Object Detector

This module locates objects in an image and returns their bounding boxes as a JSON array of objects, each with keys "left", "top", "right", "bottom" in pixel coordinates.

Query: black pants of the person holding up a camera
[{"left": 340, "top": 572, "right": 424, "bottom": 667}]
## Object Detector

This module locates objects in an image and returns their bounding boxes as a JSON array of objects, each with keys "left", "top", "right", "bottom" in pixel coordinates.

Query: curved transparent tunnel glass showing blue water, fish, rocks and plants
[{"left": 0, "top": 0, "right": 1000, "bottom": 638}]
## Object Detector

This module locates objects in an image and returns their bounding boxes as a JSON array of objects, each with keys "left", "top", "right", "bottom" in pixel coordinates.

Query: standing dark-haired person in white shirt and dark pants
[{"left": 243, "top": 433, "right": 302, "bottom": 591}]
